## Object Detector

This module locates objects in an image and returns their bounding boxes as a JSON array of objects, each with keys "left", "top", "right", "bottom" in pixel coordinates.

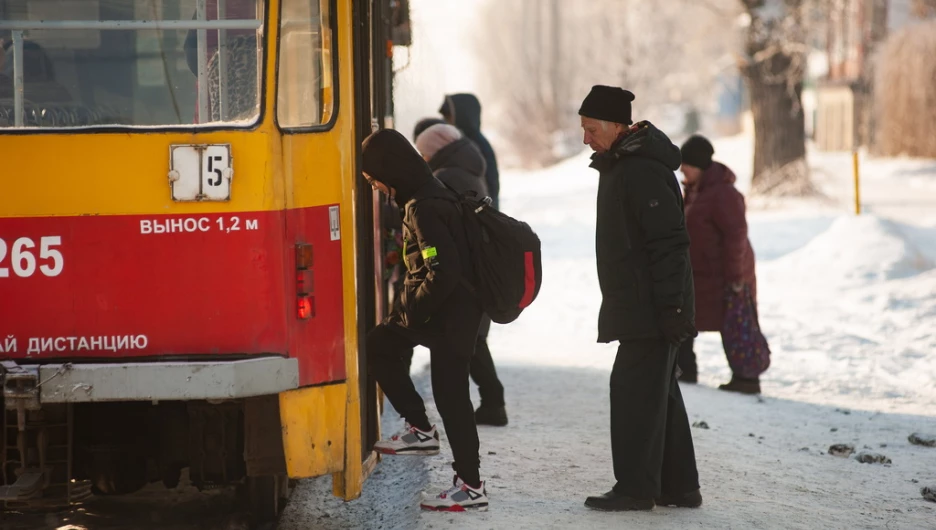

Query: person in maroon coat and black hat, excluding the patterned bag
[{"left": 679, "top": 135, "right": 760, "bottom": 394}]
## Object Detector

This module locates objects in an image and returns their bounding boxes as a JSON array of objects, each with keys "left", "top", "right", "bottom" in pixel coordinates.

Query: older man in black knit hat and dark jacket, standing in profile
[{"left": 579, "top": 85, "right": 702, "bottom": 511}]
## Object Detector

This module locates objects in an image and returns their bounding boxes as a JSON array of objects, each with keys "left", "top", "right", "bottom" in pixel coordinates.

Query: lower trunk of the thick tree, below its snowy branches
[{"left": 744, "top": 53, "right": 815, "bottom": 196}]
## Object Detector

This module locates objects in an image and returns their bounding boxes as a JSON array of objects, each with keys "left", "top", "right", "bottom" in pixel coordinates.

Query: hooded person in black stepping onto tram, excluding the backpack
[{"left": 362, "top": 129, "right": 487, "bottom": 511}]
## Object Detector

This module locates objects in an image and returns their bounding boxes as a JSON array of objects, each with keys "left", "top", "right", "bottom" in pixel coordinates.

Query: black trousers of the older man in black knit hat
[{"left": 611, "top": 338, "right": 699, "bottom": 499}]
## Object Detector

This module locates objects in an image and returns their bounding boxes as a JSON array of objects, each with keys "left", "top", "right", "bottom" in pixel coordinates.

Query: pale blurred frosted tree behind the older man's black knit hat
[{"left": 475, "top": 0, "right": 739, "bottom": 167}]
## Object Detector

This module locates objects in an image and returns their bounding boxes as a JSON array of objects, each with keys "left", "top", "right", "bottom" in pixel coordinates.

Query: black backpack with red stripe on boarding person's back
[{"left": 446, "top": 185, "right": 543, "bottom": 324}]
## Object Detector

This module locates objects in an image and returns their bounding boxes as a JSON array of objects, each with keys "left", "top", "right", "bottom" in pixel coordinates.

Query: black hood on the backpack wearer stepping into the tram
[{"left": 361, "top": 129, "right": 435, "bottom": 205}]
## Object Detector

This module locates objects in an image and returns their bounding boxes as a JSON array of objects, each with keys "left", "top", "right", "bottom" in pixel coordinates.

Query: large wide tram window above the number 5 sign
[{"left": 0, "top": 0, "right": 264, "bottom": 129}]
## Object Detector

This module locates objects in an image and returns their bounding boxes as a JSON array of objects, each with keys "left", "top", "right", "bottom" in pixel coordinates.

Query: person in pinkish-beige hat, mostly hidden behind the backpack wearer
[{"left": 416, "top": 124, "right": 507, "bottom": 427}]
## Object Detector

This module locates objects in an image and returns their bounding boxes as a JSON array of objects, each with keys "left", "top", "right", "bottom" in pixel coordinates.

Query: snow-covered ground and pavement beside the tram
[{"left": 280, "top": 136, "right": 936, "bottom": 530}]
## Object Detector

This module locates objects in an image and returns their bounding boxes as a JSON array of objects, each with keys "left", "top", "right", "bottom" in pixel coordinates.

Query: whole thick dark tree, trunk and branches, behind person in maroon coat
[{"left": 740, "top": 0, "right": 815, "bottom": 195}]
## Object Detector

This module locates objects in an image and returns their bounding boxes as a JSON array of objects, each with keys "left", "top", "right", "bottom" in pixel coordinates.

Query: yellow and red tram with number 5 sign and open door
[{"left": 0, "top": 0, "right": 408, "bottom": 518}]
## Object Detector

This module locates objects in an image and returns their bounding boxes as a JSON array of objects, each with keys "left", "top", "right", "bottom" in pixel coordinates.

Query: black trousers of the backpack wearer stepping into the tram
[{"left": 367, "top": 324, "right": 481, "bottom": 485}]
